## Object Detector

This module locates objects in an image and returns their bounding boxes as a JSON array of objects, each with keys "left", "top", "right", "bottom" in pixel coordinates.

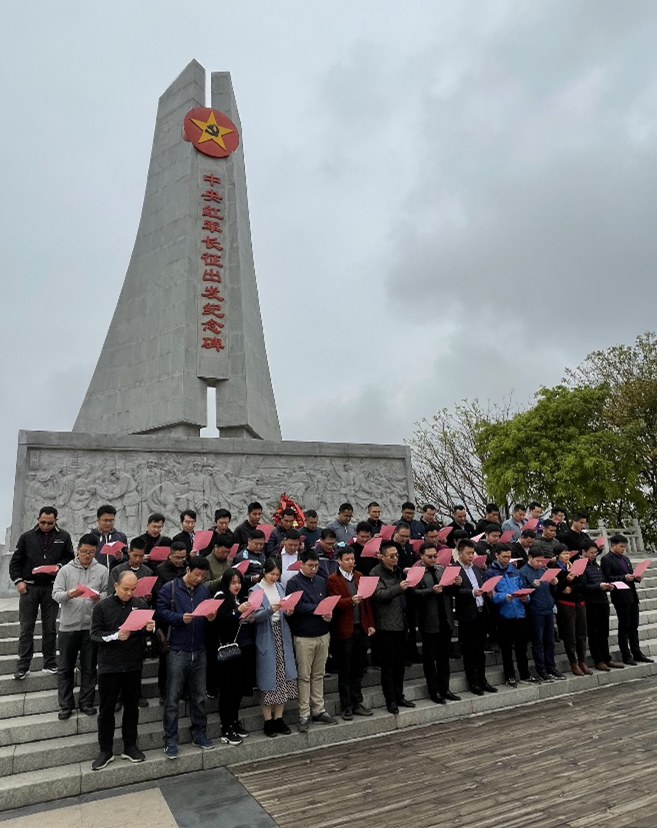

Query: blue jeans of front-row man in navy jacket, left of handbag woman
[{"left": 164, "top": 650, "right": 207, "bottom": 745}]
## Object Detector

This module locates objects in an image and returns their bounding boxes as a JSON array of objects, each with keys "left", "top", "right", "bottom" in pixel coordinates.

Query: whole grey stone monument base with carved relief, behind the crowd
[{"left": 5, "top": 431, "right": 413, "bottom": 589}]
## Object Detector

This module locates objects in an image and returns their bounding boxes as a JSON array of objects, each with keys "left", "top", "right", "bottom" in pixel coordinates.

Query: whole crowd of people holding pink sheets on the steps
[{"left": 9, "top": 494, "right": 652, "bottom": 770}]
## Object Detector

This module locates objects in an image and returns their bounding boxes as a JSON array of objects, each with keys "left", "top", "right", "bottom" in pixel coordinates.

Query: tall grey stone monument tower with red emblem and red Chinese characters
[{"left": 73, "top": 61, "right": 281, "bottom": 440}]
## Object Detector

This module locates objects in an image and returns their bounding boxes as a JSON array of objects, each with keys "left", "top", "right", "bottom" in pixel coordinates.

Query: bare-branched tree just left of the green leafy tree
[{"left": 408, "top": 399, "right": 510, "bottom": 520}]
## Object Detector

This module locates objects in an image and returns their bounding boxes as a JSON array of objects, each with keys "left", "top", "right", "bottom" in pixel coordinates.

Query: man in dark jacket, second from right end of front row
[{"left": 582, "top": 540, "right": 625, "bottom": 673}]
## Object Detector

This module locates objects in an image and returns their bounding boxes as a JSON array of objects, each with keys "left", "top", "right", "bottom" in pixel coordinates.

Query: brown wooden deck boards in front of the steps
[{"left": 230, "top": 679, "right": 657, "bottom": 828}]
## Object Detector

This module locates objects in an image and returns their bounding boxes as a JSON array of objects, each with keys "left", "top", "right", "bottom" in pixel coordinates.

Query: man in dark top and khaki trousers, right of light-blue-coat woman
[{"left": 285, "top": 549, "right": 337, "bottom": 733}]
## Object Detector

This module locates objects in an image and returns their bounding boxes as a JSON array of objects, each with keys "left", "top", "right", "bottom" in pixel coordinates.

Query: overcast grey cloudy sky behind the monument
[{"left": 0, "top": 0, "right": 657, "bottom": 527}]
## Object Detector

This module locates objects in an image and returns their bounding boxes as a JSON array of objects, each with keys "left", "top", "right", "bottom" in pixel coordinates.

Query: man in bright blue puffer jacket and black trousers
[{"left": 486, "top": 543, "right": 536, "bottom": 688}]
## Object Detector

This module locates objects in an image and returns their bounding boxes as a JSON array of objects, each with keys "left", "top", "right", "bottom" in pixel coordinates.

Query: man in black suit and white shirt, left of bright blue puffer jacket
[{"left": 455, "top": 540, "right": 497, "bottom": 696}]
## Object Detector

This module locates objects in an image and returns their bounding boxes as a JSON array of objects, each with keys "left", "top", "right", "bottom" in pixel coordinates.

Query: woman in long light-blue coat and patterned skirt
[{"left": 251, "top": 558, "right": 299, "bottom": 736}]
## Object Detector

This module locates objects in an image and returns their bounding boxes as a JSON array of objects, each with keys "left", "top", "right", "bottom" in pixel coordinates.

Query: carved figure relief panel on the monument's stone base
[{"left": 19, "top": 448, "right": 413, "bottom": 540}]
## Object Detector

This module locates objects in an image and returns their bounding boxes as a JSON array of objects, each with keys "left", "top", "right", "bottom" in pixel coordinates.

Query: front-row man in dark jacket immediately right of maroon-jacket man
[{"left": 371, "top": 544, "right": 415, "bottom": 715}]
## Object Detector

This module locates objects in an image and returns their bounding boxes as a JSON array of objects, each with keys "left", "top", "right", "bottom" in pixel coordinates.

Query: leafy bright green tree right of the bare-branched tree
[{"left": 475, "top": 384, "right": 643, "bottom": 522}]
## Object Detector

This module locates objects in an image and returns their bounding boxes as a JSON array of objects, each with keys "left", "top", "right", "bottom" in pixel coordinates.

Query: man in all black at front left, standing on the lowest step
[{"left": 91, "top": 572, "right": 155, "bottom": 770}]
